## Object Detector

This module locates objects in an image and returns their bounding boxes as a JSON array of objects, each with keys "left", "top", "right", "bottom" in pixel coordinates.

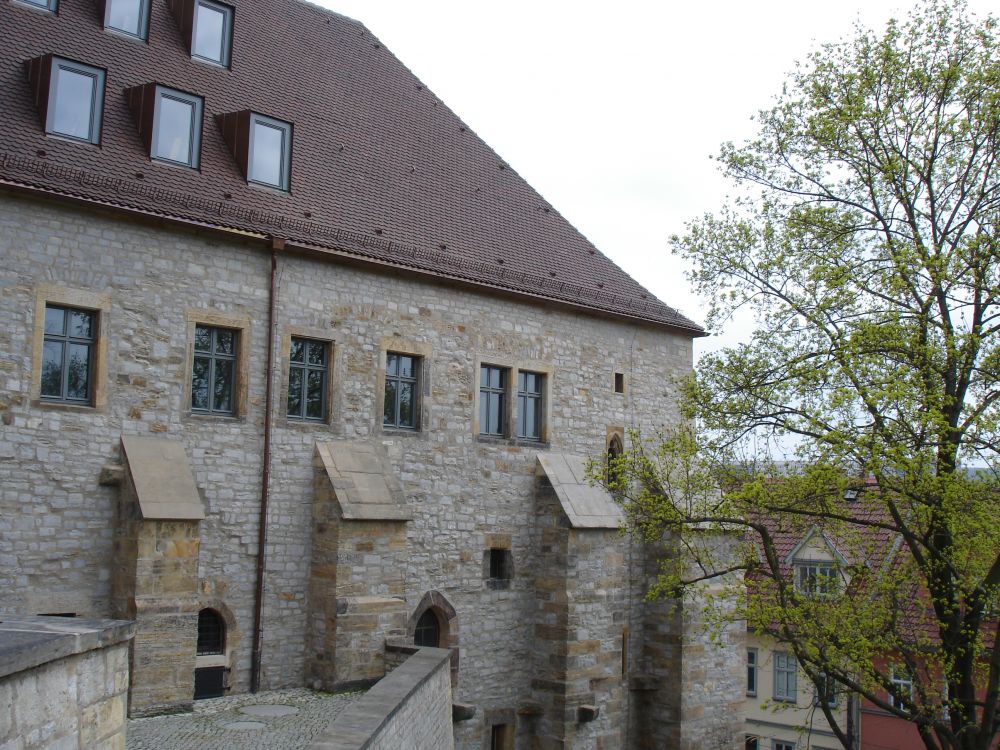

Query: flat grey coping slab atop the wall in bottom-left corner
[{"left": 0, "top": 615, "right": 135, "bottom": 679}]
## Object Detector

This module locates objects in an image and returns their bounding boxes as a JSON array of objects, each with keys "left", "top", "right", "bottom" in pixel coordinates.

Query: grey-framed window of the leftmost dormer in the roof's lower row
[{"left": 45, "top": 57, "right": 104, "bottom": 143}]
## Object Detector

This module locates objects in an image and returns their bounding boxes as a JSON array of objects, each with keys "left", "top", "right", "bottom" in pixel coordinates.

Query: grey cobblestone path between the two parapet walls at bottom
[{"left": 126, "top": 688, "right": 364, "bottom": 750}]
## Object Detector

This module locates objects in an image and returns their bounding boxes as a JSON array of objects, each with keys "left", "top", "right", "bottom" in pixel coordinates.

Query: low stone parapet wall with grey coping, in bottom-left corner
[{"left": 0, "top": 617, "right": 134, "bottom": 750}]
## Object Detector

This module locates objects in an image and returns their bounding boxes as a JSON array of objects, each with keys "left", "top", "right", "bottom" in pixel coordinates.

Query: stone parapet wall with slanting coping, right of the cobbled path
[{"left": 308, "top": 648, "right": 455, "bottom": 750}]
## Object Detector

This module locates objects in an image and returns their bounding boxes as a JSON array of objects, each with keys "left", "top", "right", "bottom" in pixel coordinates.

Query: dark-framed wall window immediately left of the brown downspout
[{"left": 191, "top": 324, "right": 239, "bottom": 415}]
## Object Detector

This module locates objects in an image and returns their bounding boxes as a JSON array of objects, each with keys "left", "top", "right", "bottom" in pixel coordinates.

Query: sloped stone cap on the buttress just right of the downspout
[{"left": 316, "top": 441, "right": 413, "bottom": 521}]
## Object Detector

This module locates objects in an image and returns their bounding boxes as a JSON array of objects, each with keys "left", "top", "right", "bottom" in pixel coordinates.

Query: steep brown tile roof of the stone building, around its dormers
[{"left": 0, "top": 0, "right": 703, "bottom": 335}]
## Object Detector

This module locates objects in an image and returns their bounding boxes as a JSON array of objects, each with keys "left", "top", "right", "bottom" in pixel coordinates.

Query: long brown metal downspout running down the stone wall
[{"left": 250, "top": 237, "right": 285, "bottom": 693}]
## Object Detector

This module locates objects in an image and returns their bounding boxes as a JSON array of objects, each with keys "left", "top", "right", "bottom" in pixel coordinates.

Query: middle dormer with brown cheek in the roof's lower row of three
[{"left": 125, "top": 83, "right": 204, "bottom": 169}]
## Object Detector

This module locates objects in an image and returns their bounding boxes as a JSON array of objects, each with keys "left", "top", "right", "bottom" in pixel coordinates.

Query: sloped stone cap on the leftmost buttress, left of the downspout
[{"left": 122, "top": 435, "right": 205, "bottom": 521}]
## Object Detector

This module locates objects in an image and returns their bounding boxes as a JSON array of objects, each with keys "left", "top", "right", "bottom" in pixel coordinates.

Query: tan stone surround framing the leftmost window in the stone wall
[{"left": 30, "top": 284, "right": 111, "bottom": 411}]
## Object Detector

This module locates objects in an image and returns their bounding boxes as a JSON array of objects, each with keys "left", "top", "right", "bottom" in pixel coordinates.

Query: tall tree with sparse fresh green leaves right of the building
[{"left": 605, "top": 0, "right": 1000, "bottom": 750}]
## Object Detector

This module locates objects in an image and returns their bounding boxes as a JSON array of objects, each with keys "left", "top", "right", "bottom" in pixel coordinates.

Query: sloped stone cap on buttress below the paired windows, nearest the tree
[{"left": 536, "top": 453, "right": 622, "bottom": 529}]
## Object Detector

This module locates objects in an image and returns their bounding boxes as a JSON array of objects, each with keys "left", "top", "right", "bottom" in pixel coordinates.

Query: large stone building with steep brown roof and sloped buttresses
[{"left": 0, "top": 0, "right": 744, "bottom": 748}]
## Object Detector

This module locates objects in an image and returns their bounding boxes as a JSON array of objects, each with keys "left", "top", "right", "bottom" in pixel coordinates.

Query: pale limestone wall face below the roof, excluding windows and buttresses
[{"left": 0, "top": 196, "right": 712, "bottom": 747}]
